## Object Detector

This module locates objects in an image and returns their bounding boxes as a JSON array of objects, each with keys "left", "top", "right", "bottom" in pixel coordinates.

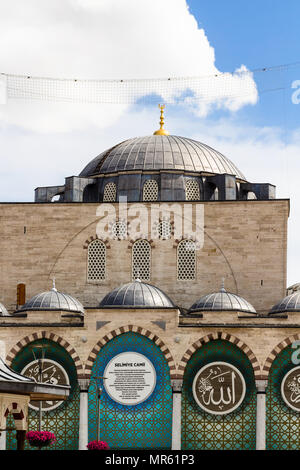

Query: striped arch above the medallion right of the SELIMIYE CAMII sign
[{"left": 177, "top": 331, "right": 261, "bottom": 380}]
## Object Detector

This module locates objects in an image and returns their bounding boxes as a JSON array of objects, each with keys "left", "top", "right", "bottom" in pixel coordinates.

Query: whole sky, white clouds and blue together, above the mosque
[{"left": 0, "top": 0, "right": 300, "bottom": 284}]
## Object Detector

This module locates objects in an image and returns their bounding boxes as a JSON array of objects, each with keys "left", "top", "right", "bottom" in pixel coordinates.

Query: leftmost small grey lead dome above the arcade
[{"left": 18, "top": 288, "right": 84, "bottom": 314}]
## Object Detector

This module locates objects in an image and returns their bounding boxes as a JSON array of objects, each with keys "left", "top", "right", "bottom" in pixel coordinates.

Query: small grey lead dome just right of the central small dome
[{"left": 188, "top": 288, "right": 256, "bottom": 314}]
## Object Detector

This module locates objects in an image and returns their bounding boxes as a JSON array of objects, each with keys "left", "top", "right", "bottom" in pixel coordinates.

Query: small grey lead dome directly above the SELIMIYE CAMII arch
[{"left": 99, "top": 280, "right": 176, "bottom": 308}]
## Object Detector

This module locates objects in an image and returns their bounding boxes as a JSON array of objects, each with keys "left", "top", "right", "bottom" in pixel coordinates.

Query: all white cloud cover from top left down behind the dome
[{"left": 0, "top": 0, "right": 300, "bottom": 284}]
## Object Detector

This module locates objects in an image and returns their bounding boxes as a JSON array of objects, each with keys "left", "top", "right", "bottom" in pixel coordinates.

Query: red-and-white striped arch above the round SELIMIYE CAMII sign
[{"left": 85, "top": 325, "right": 177, "bottom": 379}]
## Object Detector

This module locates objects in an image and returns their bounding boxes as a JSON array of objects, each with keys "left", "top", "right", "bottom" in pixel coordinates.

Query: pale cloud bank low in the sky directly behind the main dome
[{"left": 0, "top": 104, "right": 300, "bottom": 284}]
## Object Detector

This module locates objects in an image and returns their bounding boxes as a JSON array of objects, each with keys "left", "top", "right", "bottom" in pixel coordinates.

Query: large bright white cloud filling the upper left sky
[{"left": 0, "top": 0, "right": 257, "bottom": 132}]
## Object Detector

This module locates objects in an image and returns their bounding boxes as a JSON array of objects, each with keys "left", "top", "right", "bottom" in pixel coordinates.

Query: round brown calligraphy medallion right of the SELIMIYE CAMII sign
[{"left": 193, "top": 362, "right": 246, "bottom": 415}]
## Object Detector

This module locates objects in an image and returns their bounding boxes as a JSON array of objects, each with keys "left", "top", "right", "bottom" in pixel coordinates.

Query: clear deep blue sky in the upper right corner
[{"left": 188, "top": 0, "right": 300, "bottom": 132}]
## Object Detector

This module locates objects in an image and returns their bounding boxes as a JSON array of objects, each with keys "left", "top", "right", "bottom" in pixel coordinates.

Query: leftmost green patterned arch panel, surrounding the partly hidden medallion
[{"left": 7, "top": 339, "right": 79, "bottom": 450}]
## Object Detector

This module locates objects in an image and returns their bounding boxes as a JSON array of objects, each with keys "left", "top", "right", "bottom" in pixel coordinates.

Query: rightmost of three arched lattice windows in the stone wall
[{"left": 177, "top": 240, "right": 196, "bottom": 281}]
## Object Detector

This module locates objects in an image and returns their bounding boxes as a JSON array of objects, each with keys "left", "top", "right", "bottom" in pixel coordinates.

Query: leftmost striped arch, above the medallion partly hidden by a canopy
[{"left": 6, "top": 331, "right": 84, "bottom": 379}]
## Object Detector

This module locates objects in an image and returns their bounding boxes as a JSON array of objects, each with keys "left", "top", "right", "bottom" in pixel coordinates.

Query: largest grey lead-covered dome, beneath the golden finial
[{"left": 79, "top": 135, "right": 246, "bottom": 181}]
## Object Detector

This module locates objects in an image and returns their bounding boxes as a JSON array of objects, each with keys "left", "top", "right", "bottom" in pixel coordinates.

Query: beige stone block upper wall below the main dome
[{"left": 0, "top": 200, "right": 289, "bottom": 312}]
